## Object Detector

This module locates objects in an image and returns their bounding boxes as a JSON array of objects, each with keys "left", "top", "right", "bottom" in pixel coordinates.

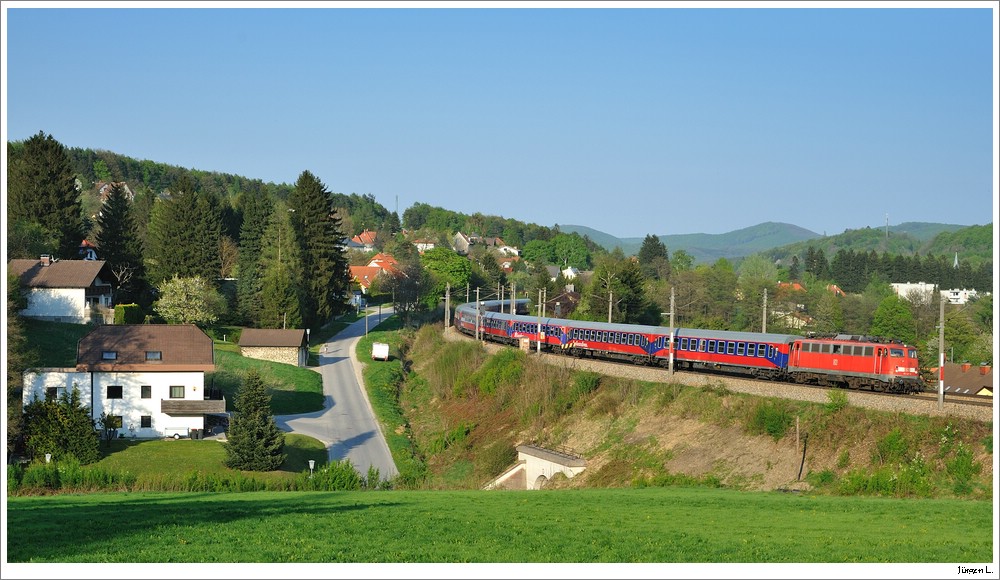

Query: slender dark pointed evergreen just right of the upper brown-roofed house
[{"left": 96, "top": 183, "right": 146, "bottom": 304}]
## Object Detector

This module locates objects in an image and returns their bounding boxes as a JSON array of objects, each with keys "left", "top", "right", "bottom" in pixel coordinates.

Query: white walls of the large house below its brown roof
[{"left": 22, "top": 369, "right": 205, "bottom": 438}]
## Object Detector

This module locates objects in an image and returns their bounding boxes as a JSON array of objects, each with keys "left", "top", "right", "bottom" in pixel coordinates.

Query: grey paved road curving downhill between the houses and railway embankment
[{"left": 274, "top": 307, "right": 399, "bottom": 479}]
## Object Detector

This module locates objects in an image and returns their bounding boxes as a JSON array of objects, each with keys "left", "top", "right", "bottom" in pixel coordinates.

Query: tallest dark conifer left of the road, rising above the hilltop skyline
[{"left": 288, "top": 171, "right": 350, "bottom": 326}]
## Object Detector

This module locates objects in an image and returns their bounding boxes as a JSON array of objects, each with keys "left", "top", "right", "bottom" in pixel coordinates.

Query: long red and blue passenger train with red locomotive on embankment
[{"left": 454, "top": 299, "right": 924, "bottom": 394}]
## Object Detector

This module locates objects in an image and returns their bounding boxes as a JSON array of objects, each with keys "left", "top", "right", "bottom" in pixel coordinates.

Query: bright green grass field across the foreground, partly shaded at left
[{"left": 7, "top": 488, "right": 993, "bottom": 563}]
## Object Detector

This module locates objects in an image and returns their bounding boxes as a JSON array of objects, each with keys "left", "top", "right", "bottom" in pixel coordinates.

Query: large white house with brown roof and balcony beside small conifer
[{"left": 22, "top": 324, "right": 226, "bottom": 438}]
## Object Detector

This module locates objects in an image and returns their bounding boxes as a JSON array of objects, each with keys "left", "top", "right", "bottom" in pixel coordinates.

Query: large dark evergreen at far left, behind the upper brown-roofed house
[{"left": 7, "top": 131, "right": 86, "bottom": 258}]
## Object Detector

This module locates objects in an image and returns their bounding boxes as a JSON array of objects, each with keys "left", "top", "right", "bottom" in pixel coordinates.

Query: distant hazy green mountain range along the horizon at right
[{"left": 559, "top": 222, "right": 992, "bottom": 263}]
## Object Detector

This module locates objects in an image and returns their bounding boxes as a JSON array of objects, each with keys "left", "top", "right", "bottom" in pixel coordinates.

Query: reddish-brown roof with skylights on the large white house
[{"left": 76, "top": 324, "right": 215, "bottom": 371}]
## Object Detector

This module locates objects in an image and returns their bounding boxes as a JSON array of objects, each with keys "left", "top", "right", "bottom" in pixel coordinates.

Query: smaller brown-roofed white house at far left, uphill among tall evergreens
[{"left": 7, "top": 256, "right": 112, "bottom": 324}]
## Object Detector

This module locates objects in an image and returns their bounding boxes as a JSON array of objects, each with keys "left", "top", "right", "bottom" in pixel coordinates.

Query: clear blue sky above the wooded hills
[{"left": 3, "top": 2, "right": 997, "bottom": 237}]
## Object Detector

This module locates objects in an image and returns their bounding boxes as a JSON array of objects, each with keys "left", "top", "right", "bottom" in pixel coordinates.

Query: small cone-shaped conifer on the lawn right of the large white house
[{"left": 225, "top": 368, "right": 285, "bottom": 471}]
